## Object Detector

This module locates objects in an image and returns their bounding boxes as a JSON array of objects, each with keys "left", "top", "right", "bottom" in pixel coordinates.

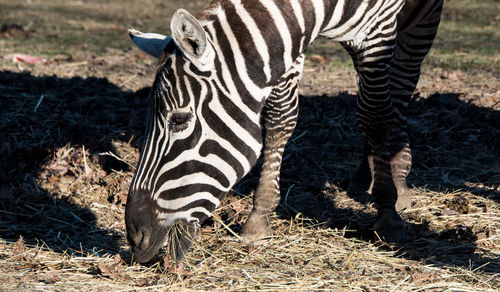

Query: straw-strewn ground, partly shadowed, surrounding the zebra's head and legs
[{"left": 0, "top": 1, "right": 500, "bottom": 291}]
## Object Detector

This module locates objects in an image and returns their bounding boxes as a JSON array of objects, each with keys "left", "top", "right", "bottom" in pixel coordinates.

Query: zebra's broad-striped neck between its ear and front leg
[{"left": 198, "top": 0, "right": 340, "bottom": 93}]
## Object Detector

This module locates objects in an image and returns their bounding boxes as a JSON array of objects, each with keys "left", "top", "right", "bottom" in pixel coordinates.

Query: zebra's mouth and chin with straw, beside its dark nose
[{"left": 165, "top": 221, "right": 200, "bottom": 263}]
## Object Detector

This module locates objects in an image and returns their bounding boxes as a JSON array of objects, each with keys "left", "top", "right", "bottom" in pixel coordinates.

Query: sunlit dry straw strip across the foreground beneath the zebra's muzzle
[{"left": 0, "top": 190, "right": 500, "bottom": 291}]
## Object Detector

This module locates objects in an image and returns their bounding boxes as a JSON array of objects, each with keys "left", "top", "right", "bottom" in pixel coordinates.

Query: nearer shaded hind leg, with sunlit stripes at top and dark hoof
[{"left": 348, "top": 23, "right": 406, "bottom": 242}]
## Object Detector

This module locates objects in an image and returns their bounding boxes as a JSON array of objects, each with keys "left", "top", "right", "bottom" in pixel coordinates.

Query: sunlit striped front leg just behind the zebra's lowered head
[{"left": 243, "top": 55, "right": 304, "bottom": 239}]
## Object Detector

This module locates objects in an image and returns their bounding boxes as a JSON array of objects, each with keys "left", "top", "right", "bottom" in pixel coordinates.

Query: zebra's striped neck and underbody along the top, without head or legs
[{"left": 198, "top": 0, "right": 410, "bottom": 89}]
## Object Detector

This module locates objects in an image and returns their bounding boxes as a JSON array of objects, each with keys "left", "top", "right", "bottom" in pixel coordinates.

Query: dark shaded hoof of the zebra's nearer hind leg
[{"left": 373, "top": 210, "right": 406, "bottom": 243}]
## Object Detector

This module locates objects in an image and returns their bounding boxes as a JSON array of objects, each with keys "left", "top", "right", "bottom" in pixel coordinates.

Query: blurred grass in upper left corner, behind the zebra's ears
[{"left": 0, "top": 0, "right": 188, "bottom": 57}]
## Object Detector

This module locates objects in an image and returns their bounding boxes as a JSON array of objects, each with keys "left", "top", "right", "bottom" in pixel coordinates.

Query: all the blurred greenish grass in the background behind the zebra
[{"left": 0, "top": 0, "right": 500, "bottom": 71}]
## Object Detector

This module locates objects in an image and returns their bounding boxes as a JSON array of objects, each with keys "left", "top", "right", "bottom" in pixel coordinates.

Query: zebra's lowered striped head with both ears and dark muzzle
[{"left": 125, "top": 9, "right": 262, "bottom": 262}]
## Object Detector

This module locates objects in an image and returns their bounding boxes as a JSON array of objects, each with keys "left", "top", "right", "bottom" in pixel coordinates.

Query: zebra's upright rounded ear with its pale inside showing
[{"left": 170, "top": 9, "right": 211, "bottom": 64}]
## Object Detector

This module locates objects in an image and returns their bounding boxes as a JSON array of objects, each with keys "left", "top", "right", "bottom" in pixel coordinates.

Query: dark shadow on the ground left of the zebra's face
[{"left": 0, "top": 71, "right": 148, "bottom": 254}]
